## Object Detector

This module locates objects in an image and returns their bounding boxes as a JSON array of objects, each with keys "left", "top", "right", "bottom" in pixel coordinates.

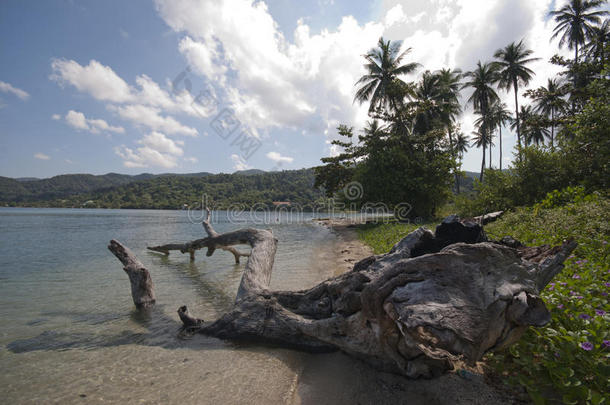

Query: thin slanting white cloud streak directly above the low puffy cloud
[{"left": 108, "top": 104, "right": 197, "bottom": 136}]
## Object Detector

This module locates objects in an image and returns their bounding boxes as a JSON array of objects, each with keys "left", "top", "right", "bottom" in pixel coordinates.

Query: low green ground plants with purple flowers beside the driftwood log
[{"left": 358, "top": 197, "right": 610, "bottom": 404}]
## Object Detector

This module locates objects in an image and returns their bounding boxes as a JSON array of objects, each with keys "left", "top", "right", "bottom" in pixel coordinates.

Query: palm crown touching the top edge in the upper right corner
[{"left": 549, "top": 0, "right": 608, "bottom": 64}]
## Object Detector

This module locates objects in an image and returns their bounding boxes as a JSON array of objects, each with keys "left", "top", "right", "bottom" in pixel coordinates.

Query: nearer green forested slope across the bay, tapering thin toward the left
[{"left": 6, "top": 169, "right": 323, "bottom": 210}]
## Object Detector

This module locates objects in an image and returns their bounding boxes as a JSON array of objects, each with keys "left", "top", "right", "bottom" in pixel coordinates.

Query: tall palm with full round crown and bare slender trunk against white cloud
[{"left": 494, "top": 40, "right": 539, "bottom": 150}]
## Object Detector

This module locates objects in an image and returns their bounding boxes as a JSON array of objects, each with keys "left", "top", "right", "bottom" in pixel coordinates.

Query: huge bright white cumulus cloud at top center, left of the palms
[{"left": 156, "top": 0, "right": 384, "bottom": 133}]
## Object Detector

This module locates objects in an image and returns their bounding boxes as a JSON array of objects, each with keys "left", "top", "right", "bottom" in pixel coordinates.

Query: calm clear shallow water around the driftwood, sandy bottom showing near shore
[{"left": 0, "top": 209, "right": 336, "bottom": 403}]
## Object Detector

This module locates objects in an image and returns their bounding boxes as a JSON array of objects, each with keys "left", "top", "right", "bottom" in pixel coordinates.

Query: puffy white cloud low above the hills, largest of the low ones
[{"left": 114, "top": 132, "right": 184, "bottom": 169}]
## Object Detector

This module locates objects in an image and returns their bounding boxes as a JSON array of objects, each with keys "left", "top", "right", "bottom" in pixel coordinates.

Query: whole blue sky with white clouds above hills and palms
[{"left": 0, "top": 0, "right": 592, "bottom": 177}]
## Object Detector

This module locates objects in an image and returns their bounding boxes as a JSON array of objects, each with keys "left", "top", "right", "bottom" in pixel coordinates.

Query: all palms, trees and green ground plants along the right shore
[{"left": 330, "top": 0, "right": 610, "bottom": 404}]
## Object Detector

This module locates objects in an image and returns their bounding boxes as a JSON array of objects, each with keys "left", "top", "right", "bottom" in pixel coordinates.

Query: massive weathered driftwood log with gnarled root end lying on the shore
[{"left": 111, "top": 216, "right": 576, "bottom": 378}]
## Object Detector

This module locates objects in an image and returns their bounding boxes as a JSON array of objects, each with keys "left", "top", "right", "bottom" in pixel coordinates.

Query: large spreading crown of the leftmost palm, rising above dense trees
[{"left": 354, "top": 37, "right": 419, "bottom": 114}]
